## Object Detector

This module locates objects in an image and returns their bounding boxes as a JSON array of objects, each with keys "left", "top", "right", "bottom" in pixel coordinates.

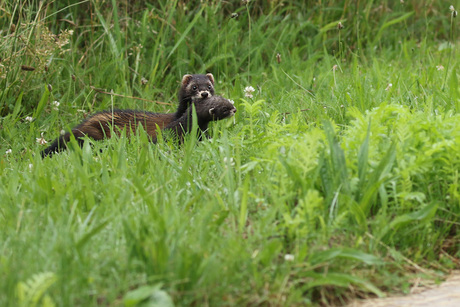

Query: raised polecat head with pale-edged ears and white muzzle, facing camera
[{"left": 181, "top": 74, "right": 214, "bottom": 101}]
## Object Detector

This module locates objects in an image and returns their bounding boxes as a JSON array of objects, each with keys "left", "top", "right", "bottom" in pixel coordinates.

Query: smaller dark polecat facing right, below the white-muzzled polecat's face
[{"left": 153, "top": 96, "right": 236, "bottom": 143}]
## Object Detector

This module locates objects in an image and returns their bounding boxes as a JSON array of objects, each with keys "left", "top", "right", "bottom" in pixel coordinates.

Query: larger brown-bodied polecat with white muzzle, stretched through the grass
[{"left": 41, "top": 74, "right": 214, "bottom": 157}]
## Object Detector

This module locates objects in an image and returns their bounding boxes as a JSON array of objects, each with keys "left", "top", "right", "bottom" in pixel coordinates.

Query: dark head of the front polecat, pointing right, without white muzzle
[{"left": 195, "top": 96, "right": 236, "bottom": 121}]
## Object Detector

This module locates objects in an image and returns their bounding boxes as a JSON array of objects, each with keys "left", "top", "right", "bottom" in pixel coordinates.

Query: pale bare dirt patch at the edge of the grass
[{"left": 348, "top": 271, "right": 460, "bottom": 307}]
